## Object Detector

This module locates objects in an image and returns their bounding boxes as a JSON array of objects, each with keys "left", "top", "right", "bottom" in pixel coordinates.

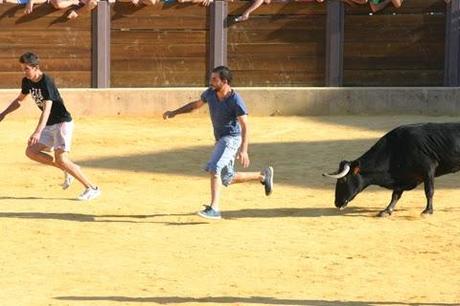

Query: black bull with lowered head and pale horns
[{"left": 324, "top": 123, "right": 460, "bottom": 217}]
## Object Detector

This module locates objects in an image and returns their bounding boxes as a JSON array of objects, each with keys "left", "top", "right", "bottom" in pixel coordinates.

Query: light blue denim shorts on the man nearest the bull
[{"left": 205, "top": 136, "right": 241, "bottom": 186}]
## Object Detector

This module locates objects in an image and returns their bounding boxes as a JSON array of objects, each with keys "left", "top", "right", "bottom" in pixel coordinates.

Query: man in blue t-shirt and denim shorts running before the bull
[{"left": 163, "top": 66, "right": 274, "bottom": 219}]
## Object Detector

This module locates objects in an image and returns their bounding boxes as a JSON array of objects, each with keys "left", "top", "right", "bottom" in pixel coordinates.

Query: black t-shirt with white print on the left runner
[{"left": 21, "top": 73, "right": 72, "bottom": 125}]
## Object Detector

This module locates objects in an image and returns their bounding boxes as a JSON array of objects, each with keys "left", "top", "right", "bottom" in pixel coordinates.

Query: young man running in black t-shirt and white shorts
[{"left": 0, "top": 52, "right": 101, "bottom": 201}]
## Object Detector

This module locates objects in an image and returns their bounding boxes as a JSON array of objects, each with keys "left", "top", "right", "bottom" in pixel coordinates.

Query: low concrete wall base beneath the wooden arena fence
[{"left": 0, "top": 87, "right": 460, "bottom": 117}]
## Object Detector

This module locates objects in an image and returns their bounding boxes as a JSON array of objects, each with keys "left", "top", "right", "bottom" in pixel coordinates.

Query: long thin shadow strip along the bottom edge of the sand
[{"left": 55, "top": 296, "right": 458, "bottom": 306}]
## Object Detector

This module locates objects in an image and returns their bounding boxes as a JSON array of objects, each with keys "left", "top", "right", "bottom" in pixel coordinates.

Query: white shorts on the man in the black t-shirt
[{"left": 38, "top": 121, "right": 73, "bottom": 152}]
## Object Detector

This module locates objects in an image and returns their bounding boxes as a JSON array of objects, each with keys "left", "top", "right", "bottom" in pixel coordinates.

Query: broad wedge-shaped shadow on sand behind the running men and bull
[{"left": 78, "top": 138, "right": 460, "bottom": 190}]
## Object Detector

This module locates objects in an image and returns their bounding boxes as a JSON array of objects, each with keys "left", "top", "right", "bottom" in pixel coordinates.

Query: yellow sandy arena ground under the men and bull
[{"left": 0, "top": 115, "right": 460, "bottom": 306}]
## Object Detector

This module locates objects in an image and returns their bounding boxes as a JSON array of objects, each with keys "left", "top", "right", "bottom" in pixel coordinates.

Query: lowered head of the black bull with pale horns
[{"left": 323, "top": 161, "right": 365, "bottom": 209}]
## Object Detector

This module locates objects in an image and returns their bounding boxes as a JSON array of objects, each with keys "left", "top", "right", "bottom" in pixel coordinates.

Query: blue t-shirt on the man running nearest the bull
[{"left": 201, "top": 88, "right": 248, "bottom": 140}]
